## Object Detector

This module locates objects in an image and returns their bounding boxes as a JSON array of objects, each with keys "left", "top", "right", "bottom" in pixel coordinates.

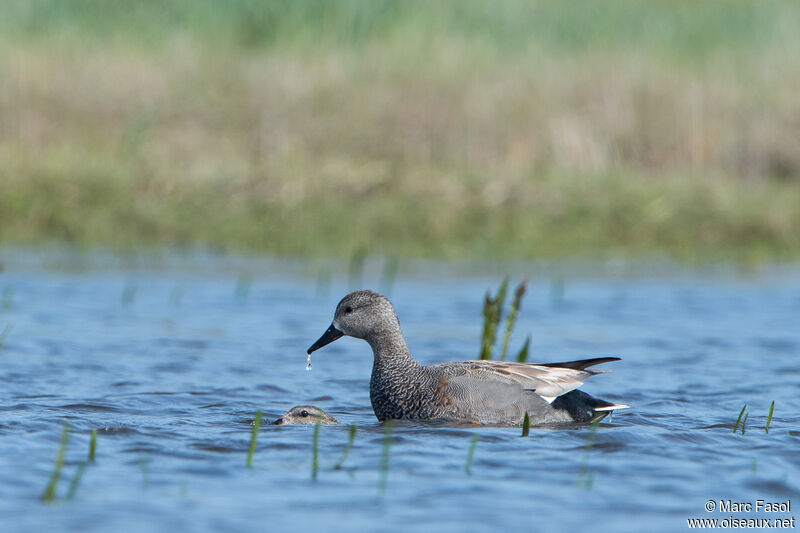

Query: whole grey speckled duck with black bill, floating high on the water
[{"left": 308, "top": 291, "right": 627, "bottom": 425}]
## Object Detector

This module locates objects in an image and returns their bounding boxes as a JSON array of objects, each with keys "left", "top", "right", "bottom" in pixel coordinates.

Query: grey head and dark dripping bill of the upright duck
[{"left": 308, "top": 291, "right": 400, "bottom": 354}]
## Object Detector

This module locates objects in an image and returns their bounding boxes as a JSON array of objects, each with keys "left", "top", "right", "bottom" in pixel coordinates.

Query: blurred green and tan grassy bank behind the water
[{"left": 0, "top": 0, "right": 800, "bottom": 261}]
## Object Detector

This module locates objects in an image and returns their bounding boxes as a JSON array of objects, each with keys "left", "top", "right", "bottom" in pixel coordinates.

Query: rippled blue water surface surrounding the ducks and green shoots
[{"left": 0, "top": 254, "right": 800, "bottom": 531}]
